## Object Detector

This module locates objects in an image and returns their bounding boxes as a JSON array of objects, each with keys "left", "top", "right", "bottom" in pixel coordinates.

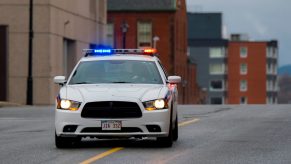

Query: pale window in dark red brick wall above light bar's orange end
[{"left": 137, "top": 22, "right": 152, "bottom": 48}]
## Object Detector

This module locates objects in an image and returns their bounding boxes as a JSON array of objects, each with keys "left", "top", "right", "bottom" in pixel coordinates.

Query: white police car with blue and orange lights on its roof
[{"left": 54, "top": 49, "right": 181, "bottom": 148}]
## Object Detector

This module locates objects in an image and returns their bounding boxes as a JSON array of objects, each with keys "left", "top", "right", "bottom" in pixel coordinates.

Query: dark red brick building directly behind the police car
[{"left": 107, "top": 0, "right": 202, "bottom": 104}]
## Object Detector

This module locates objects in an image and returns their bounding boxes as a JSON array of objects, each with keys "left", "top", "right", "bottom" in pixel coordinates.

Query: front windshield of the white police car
[{"left": 69, "top": 60, "right": 163, "bottom": 84}]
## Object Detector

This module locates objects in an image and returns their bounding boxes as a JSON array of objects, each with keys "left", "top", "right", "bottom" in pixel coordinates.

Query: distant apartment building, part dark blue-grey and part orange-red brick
[{"left": 188, "top": 13, "right": 278, "bottom": 104}]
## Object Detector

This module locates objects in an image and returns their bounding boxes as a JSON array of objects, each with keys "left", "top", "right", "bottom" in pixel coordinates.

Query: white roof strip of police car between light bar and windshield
[{"left": 80, "top": 54, "right": 158, "bottom": 62}]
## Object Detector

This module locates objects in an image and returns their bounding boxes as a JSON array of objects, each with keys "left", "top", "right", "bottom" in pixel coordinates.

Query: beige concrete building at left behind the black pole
[{"left": 0, "top": 0, "right": 106, "bottom": 105}]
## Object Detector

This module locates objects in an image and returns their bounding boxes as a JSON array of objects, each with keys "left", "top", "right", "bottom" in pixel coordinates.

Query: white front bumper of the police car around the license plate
[{"left": 55, "top": 109, "right": 170, "bottom": 138}]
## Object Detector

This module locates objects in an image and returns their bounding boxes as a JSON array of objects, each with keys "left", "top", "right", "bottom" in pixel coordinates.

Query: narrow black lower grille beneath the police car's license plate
[{"left": 81, "top": 127, "right": 142, "bottom": 133}]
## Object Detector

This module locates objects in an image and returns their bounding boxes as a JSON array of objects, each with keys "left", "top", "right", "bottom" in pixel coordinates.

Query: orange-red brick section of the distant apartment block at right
[{"left": 227, "top": 36, "right": 278, "bottom": 104}]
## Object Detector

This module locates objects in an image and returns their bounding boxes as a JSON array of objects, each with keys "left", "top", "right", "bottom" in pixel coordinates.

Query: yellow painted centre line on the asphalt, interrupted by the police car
[{"left": 80, "top": 118, "right": 200, "bottom": 164}]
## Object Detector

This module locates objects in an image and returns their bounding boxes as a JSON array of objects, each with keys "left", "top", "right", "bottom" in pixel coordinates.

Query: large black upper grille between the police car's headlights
[{"left": 81, "top": 101, "right": 142, "bottom": 118}]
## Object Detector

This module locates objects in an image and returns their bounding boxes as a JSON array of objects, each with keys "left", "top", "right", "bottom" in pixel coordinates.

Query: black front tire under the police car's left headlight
[{"left": 55, "top": 134, "right": 81, "bottom": 149}]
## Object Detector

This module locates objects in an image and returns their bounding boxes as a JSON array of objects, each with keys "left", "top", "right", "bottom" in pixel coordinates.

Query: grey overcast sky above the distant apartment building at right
[{"left": 187, "top": 0, "right": 291, "bottom": 66}]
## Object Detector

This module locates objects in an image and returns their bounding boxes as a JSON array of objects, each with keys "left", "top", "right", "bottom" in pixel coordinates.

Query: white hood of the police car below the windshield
[{"left": 61, "top": 84, "right": 167, "bottom": 102}]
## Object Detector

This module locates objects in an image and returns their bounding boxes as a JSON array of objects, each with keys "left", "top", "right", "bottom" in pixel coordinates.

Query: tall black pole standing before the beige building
[{"left": 26, "top": 0, "right": 33, "bottom": 105}]
